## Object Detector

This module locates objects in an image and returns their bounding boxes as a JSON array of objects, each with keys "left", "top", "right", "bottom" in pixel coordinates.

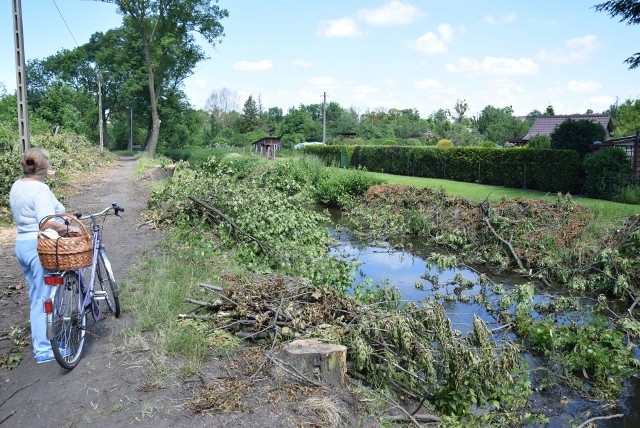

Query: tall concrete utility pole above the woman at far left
[{"left": 11, "top": 0, "right": 31, "bottom": 154}]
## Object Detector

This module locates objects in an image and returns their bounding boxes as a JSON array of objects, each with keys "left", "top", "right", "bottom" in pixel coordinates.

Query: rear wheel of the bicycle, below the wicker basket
[{"left": 47, "top": 271, "right": 87, "bottom": 370}]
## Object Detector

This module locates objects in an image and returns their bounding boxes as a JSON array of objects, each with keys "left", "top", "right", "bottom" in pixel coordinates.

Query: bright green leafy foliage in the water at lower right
[{"left": 499, "top": 284, "right": 640, "bottom": 398}]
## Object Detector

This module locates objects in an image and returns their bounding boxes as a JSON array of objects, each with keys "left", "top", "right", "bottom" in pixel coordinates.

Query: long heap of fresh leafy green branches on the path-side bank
[{"left": 152, "top": 158, "right": 358, "bottom": 292}]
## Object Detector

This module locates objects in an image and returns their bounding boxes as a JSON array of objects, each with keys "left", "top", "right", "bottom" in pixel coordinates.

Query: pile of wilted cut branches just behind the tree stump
[{"left": 181, "top": 275, "right": 522, "bottom": 418}]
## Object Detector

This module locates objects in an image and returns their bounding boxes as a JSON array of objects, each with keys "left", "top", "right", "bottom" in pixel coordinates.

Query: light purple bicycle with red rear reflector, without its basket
[{"left": 44, "top": 203, "right": 124, "bottom": 370}]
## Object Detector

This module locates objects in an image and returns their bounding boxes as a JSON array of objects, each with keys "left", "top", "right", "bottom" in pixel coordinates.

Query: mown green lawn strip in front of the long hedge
[{"left": 369, "top": 172, "right": 640, "bottom": 221}]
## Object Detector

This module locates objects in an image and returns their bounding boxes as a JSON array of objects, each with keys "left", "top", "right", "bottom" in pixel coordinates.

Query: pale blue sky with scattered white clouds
[{"left": 0, "top": 0, "right": 640, "bottom": 117}]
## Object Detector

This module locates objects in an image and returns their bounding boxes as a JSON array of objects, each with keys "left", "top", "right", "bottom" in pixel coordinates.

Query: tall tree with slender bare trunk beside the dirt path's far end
[{"left": 98, "top": 0, "right": 229, "bottom": 157}]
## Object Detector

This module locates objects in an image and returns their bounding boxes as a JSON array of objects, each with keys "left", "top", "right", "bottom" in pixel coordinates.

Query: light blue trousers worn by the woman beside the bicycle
[{"left": 16, "top": 239, "right": 52, "bottom": 357}]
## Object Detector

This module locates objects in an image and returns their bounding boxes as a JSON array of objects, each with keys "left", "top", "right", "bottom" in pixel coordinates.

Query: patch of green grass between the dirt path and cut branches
[{"left": 122, "top": 233, "right": 241, "bottom": 366}]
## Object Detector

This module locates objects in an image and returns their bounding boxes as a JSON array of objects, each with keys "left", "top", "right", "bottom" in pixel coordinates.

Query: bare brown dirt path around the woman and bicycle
[{"left": 0, "top": 158, "right": 380, "bottom": 428}]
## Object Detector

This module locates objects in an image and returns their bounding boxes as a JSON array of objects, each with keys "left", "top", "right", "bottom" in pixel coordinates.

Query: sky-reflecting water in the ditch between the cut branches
[{"left": 330, "top": 228, "right": 640, "bottom": 428}]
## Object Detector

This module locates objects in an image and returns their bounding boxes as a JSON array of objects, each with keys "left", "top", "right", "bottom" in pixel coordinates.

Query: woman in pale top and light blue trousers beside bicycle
[{"left": 9, "top": 148, "right": 80, "bottom": 364}]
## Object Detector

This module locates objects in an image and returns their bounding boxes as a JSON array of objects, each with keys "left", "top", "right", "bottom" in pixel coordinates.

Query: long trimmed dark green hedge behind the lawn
[{"left": 306, "top": 145, "right": 584, "bottom": 193}]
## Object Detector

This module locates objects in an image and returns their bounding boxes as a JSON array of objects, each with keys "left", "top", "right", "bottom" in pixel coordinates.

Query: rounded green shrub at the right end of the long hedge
[{"left": 584, "top": 147, "right": 631, "bottom": 200}]
